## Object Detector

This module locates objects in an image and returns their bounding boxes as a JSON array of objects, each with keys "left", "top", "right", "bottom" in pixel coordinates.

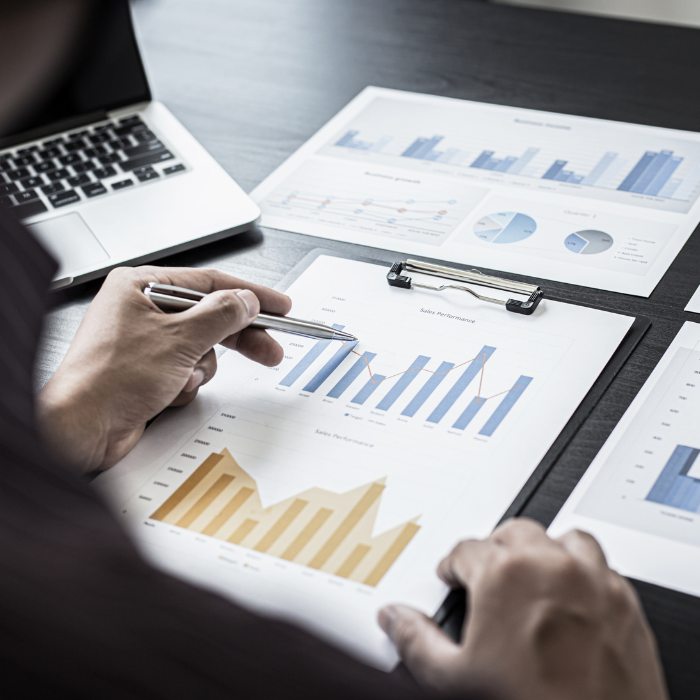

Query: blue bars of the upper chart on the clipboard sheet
[{"left": 279, "top": 334, "right": 532, "bottom": 437}]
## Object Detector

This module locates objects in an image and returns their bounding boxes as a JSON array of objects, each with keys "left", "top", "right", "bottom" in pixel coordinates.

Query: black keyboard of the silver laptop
[{"left": 0, "top": 116, "right": 187, "bottom": 219}]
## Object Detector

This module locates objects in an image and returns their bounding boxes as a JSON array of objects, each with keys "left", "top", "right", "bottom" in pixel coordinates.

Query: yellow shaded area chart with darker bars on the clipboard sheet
[{"left": 151, "top": 449, "right": 420, "bottom": 586}]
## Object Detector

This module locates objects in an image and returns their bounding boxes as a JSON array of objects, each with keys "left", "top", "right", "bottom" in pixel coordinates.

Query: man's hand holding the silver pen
[{"left": 37, "top": 266, "right": 291, "bottom": 472}]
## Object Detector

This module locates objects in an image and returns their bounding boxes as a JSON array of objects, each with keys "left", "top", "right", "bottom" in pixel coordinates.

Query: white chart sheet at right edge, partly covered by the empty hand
[{"left": 549, "top": 323, "right": 700, "bottom": 595}]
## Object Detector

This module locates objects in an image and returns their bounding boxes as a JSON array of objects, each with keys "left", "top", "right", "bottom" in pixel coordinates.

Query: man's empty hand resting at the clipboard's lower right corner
[{"left": 379, "top": 520, "right": 667, "bottom": 700}]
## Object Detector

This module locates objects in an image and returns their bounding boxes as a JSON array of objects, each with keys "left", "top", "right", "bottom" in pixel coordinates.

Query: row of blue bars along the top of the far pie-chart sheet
[{"left": 334, "top": 129, "right": 700, "bottom": 201}]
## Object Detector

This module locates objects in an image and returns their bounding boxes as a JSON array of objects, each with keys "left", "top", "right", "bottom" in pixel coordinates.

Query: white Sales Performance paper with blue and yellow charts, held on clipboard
[{"left": 96, "top": 256, "right": 632, "bottom": 669}]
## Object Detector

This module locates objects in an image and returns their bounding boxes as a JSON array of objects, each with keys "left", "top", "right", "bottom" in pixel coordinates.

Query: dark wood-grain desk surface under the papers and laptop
[{"left": 43, "top": 0, "right": 700, "bottom": 700}]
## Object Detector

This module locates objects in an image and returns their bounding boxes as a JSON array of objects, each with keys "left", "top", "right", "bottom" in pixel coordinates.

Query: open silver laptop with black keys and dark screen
[{"left": 0, "top": 0, "right": 260, "bottom": 289}]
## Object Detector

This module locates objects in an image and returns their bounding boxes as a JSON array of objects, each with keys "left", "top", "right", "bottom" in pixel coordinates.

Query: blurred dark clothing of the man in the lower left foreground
[{"left": 0, "top": 211, "right": 494, "bottom": 700}]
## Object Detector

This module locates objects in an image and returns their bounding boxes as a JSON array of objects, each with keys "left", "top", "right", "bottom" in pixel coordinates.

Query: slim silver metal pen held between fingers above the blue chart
[{"left": 143, "top": 282, "right": 357, "bottom": 342}]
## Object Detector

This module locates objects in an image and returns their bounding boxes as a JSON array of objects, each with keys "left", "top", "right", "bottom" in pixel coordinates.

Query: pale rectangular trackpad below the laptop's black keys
[{"left": 28, "top": 213, "right": 109, "bottom": 277}]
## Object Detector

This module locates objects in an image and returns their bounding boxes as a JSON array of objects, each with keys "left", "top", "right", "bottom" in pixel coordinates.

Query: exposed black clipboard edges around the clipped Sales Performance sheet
[{"left": 275, "top": 248, "right": 651, "bottom": 648}]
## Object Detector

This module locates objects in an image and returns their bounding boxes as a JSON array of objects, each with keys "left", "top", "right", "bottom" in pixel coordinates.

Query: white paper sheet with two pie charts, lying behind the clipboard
[{"left": 251, "top": 87, "right": 700, "bottom": 296}]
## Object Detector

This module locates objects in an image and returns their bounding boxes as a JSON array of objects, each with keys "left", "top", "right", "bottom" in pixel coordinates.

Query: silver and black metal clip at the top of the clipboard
[{"left": 386, "top": 260, "right": 544, "bottom": 316}]
